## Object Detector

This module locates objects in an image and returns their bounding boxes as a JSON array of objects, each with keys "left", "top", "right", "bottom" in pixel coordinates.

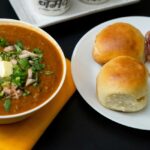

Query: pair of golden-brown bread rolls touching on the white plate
[{"left": 92, "top": 22, "right": 148, "bottom": 112}]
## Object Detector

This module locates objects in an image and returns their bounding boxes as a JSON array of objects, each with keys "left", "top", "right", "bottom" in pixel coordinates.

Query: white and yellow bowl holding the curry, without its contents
[{"left": 0, "top": 19, "right": 66, "bottom": 124}]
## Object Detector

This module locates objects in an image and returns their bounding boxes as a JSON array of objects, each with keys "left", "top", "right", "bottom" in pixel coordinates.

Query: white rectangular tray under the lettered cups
[{"left": 9, "top": 0, "right": 140, "bottom": 27}]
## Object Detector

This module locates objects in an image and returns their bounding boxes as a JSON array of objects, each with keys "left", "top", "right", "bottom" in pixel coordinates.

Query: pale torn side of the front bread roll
[{"left": 103, "top": 93, "right": 147, "bottom": 112}]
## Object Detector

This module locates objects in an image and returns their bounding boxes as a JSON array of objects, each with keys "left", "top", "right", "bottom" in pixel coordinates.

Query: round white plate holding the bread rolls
[{"left": 71, "top": 16, "right": 150, "bottom": 130}]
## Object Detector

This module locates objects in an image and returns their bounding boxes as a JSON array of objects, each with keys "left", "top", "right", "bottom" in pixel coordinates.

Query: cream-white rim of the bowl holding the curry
[{"left": 0, "top": 19, "right": 67, "bottom": 119}]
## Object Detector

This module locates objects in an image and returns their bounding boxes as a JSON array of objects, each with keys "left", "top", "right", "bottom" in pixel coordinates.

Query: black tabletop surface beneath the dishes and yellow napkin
[{"left": 0, "top": 0, "right": 150, "bottom": 150}]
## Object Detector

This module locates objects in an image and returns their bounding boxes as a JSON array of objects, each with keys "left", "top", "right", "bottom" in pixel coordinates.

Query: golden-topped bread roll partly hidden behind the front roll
[{"left": 93, "top": 22, "right": 144, "bottom": 64}]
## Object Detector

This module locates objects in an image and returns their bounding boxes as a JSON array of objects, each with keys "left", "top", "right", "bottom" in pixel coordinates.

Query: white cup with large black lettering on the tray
[{"left": 33, "top": 0, "right": 70, "bottom": 16}]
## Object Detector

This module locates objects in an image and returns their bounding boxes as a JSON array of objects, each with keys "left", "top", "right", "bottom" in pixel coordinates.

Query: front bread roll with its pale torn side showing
[{"left": 96, "top": 56, "right": 148, "bottom": 112}]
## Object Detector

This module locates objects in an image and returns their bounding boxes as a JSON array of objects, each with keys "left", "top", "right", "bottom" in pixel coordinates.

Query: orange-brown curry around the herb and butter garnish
[{"left": 0, "top": 24, "right": 63, "bottom": 115}]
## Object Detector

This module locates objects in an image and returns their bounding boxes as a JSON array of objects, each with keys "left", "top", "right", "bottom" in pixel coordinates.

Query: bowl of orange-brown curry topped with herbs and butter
[{"left": 0, "top": 19, "right": 66, "bottom": 124}]
